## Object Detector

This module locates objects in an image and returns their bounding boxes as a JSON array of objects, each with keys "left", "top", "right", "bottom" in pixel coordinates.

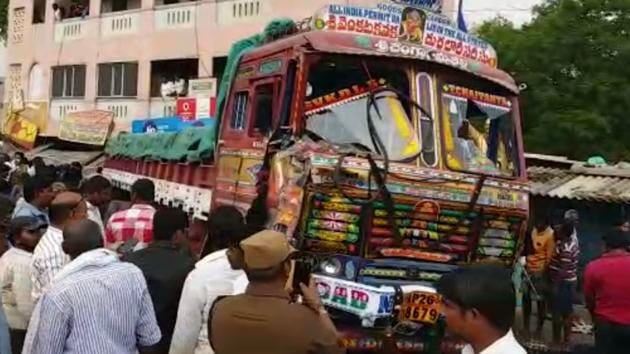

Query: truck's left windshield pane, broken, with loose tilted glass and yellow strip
[{"left": 305, "top": 57, "right": 421, "bottom": 161}]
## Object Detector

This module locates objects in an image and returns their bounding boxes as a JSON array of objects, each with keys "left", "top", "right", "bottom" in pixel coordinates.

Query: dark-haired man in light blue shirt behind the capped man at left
[{"left": 13, "top": 177, "right": 55, "bottom": 224}]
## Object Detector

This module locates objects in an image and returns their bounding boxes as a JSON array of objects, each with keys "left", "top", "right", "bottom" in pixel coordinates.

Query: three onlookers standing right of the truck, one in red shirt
[{"left": 523, "top": 210, "right": 630, "bottom": 354}]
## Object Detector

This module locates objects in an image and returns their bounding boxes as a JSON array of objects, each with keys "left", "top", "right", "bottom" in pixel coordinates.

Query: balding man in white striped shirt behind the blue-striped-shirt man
[{"left": 31, "top": 192, "right": 87, "bottom": 302}]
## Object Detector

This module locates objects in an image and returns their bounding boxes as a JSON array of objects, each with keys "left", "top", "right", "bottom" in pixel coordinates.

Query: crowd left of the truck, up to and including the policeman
[{"left": 0, "top": 153, "right": 350, "bottom": 354}]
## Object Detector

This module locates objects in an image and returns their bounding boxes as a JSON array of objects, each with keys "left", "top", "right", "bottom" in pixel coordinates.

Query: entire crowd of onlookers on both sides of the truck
[{"left": 0, "top": 149, "right": 630, "bottom": 354}]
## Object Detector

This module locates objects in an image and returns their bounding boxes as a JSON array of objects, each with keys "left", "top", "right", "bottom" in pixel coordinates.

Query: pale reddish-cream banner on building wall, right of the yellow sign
[{"left": 59, "top": 110, "right": 113, "bottom": 145}]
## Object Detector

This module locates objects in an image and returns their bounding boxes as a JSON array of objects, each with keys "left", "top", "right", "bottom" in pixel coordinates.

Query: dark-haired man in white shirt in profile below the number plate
[{"left": 437, "top": 265, "right": 527, "bottom": 354}]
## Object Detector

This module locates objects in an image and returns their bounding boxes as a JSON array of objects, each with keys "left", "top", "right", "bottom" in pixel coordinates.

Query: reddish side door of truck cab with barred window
[{"left": 215, "top": 71, "right": 282, "bottom": 212}]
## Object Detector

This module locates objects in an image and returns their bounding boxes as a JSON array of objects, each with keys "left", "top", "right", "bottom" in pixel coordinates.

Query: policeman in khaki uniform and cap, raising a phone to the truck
[{"left": 208, "top": 230, "right": 344, "bottom": 354}]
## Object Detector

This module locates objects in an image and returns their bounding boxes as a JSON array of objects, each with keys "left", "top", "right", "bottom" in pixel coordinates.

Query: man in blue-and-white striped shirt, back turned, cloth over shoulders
[{"left": 23, "top": 220, "right": 161, "bottom": 354}]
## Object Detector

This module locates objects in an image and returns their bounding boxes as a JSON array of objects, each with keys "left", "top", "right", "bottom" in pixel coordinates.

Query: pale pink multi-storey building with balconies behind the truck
[{"left": 5, "top": 0, "right": 460, "bottom": 136}]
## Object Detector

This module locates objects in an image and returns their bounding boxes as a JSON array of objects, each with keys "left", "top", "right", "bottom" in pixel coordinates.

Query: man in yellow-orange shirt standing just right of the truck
[{"left": 523, "top": 216, "right": 555, "bottom": 336}]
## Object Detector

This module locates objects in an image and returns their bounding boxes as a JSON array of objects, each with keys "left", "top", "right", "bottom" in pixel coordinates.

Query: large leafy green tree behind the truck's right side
[{"left": 477, "top": 0, "right": 630, "bottom": 160}]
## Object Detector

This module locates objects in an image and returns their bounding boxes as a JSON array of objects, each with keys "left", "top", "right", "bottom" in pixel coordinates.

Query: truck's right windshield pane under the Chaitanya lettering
[{"left": 442, "top": 84, "right": 519, "bottom": 177}]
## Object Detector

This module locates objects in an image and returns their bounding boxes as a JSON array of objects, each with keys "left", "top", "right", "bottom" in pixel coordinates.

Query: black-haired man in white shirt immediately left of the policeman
[{"left": 169, "top": 206, "right": 253, "bottom": 354}]
